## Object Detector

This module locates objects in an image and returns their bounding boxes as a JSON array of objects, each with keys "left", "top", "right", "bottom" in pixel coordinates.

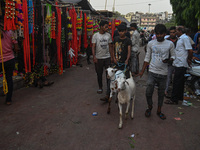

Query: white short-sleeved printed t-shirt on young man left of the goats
[{"left": 92, "top": 32, "right": 112, "bottom": 59}]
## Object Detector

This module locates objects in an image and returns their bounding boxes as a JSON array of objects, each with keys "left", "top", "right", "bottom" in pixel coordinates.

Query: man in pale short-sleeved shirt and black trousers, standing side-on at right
[{"left": 165, "top": 26, "right": 192, "bottom": 104}]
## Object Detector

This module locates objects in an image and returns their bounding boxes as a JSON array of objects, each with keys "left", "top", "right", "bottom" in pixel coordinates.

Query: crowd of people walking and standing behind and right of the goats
[{"left": 92, "top": 21, "right": 200, "bottom": 120}]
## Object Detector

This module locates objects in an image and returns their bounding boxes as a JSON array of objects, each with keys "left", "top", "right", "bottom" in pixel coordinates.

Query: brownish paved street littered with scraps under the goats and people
[{"left": 0, "top": 47, "right": 200, "bottom": 150}]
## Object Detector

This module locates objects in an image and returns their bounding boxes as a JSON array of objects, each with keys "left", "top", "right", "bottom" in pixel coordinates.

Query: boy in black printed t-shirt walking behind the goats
[{"left": 113, "top": 24, "right": 131, "bottom": 78}]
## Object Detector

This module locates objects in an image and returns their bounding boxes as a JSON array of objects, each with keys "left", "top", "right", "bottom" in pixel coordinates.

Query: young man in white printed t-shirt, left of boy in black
[{"left": 92, "top": 21, "right": 112, "bottom": 100}]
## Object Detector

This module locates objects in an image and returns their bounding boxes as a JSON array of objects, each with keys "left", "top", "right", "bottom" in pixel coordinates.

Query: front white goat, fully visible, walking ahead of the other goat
[{"left": 117, "top": 72, "right": 136, "bottom": 129}]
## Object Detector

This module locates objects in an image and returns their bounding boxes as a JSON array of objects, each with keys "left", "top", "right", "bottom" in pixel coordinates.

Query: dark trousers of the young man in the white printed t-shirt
[{"left": 95, "top": 58, "right": 111, "bottom": 95}]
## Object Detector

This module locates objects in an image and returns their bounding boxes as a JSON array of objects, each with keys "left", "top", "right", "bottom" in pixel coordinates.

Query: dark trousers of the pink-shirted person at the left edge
[{"left": 0, "top": 59, "right": 15, "bottom": 102}]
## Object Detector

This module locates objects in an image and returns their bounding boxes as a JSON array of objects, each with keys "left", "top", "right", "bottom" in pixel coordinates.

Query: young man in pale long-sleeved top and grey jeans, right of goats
[{"left": 138, "top": 24, "right": 175, "bottom": 120}]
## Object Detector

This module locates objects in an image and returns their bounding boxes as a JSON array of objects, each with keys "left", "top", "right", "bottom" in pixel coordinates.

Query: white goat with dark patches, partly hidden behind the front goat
[{"left": 106, "top": 67, "right": 125, "bottom": 114}]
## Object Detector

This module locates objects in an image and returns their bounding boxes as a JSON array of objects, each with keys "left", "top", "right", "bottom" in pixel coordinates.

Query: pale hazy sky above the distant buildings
[{"left": 88, "top": 0, "right": 173, "bottom": 15}]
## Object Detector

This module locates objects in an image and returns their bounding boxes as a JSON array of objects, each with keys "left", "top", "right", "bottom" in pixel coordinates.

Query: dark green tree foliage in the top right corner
[{"left": 170, "top": 0, "right": 200, "bottom": 30}]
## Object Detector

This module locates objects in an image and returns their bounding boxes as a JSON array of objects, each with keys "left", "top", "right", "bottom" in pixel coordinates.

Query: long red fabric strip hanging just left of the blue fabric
[{"left": 22, "top": 0, "right": 31, "bottom": 73}]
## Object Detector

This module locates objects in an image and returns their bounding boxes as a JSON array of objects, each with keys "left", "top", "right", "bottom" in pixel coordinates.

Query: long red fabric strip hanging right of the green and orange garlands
[{"left": 56, "top": 2, "right": 63, "bottom": 74}]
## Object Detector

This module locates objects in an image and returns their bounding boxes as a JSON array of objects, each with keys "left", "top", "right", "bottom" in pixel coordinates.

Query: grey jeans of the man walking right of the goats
[{"left": 146, "top": 72, "right": 167, "bottom": 107}]
